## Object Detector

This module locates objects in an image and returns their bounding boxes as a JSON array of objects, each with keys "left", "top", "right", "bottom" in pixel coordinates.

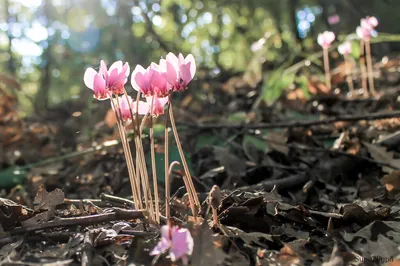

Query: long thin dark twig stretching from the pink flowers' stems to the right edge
[{"left": 178, "top": 111, "right": 400, "bottom": 130}]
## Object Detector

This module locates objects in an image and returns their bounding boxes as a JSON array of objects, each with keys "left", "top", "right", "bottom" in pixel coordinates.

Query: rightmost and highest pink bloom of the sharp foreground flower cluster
[{"left": 160, "top": 53, "right": 196, "bottom": 91}]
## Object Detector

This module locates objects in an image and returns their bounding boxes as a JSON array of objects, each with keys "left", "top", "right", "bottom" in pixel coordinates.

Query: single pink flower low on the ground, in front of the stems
[{"left": 150, "top": 225, "right": 194, "bottom": 264}]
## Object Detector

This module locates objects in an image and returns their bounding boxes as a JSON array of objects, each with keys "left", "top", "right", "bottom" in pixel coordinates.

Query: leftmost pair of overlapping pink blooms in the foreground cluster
[{"left": 83, "top": 60, "right": 129, "bottom": 100}]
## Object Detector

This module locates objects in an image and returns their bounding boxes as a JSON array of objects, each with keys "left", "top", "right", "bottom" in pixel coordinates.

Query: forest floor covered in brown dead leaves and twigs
[{"left": 0, "top": 59, "right": 400, "bottom": 266}]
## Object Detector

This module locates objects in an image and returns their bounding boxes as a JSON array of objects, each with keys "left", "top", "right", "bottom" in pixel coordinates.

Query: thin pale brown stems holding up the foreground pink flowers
[{"left": 110, "top": 90, "right": 200, "bottom": 223}]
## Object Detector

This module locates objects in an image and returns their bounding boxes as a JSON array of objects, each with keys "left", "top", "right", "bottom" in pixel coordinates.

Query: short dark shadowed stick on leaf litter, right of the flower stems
[{"left": 238, "top": 173, "right": 310, "bottom": 190}]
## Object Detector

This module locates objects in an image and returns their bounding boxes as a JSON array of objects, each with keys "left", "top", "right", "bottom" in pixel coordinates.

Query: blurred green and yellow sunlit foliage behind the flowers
[{"left": 0, "top": 0, "right": 400, "bottom": 114}]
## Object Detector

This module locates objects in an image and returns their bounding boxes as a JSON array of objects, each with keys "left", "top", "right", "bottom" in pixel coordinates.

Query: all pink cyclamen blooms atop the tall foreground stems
[{"left": 84, "top": 53, "right": 196, "bottom": 121}]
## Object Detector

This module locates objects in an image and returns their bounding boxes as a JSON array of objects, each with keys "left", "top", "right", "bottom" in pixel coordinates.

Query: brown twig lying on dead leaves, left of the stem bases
[{"left": 10, "top": 208, "right": 145, "bottom": 235}]
